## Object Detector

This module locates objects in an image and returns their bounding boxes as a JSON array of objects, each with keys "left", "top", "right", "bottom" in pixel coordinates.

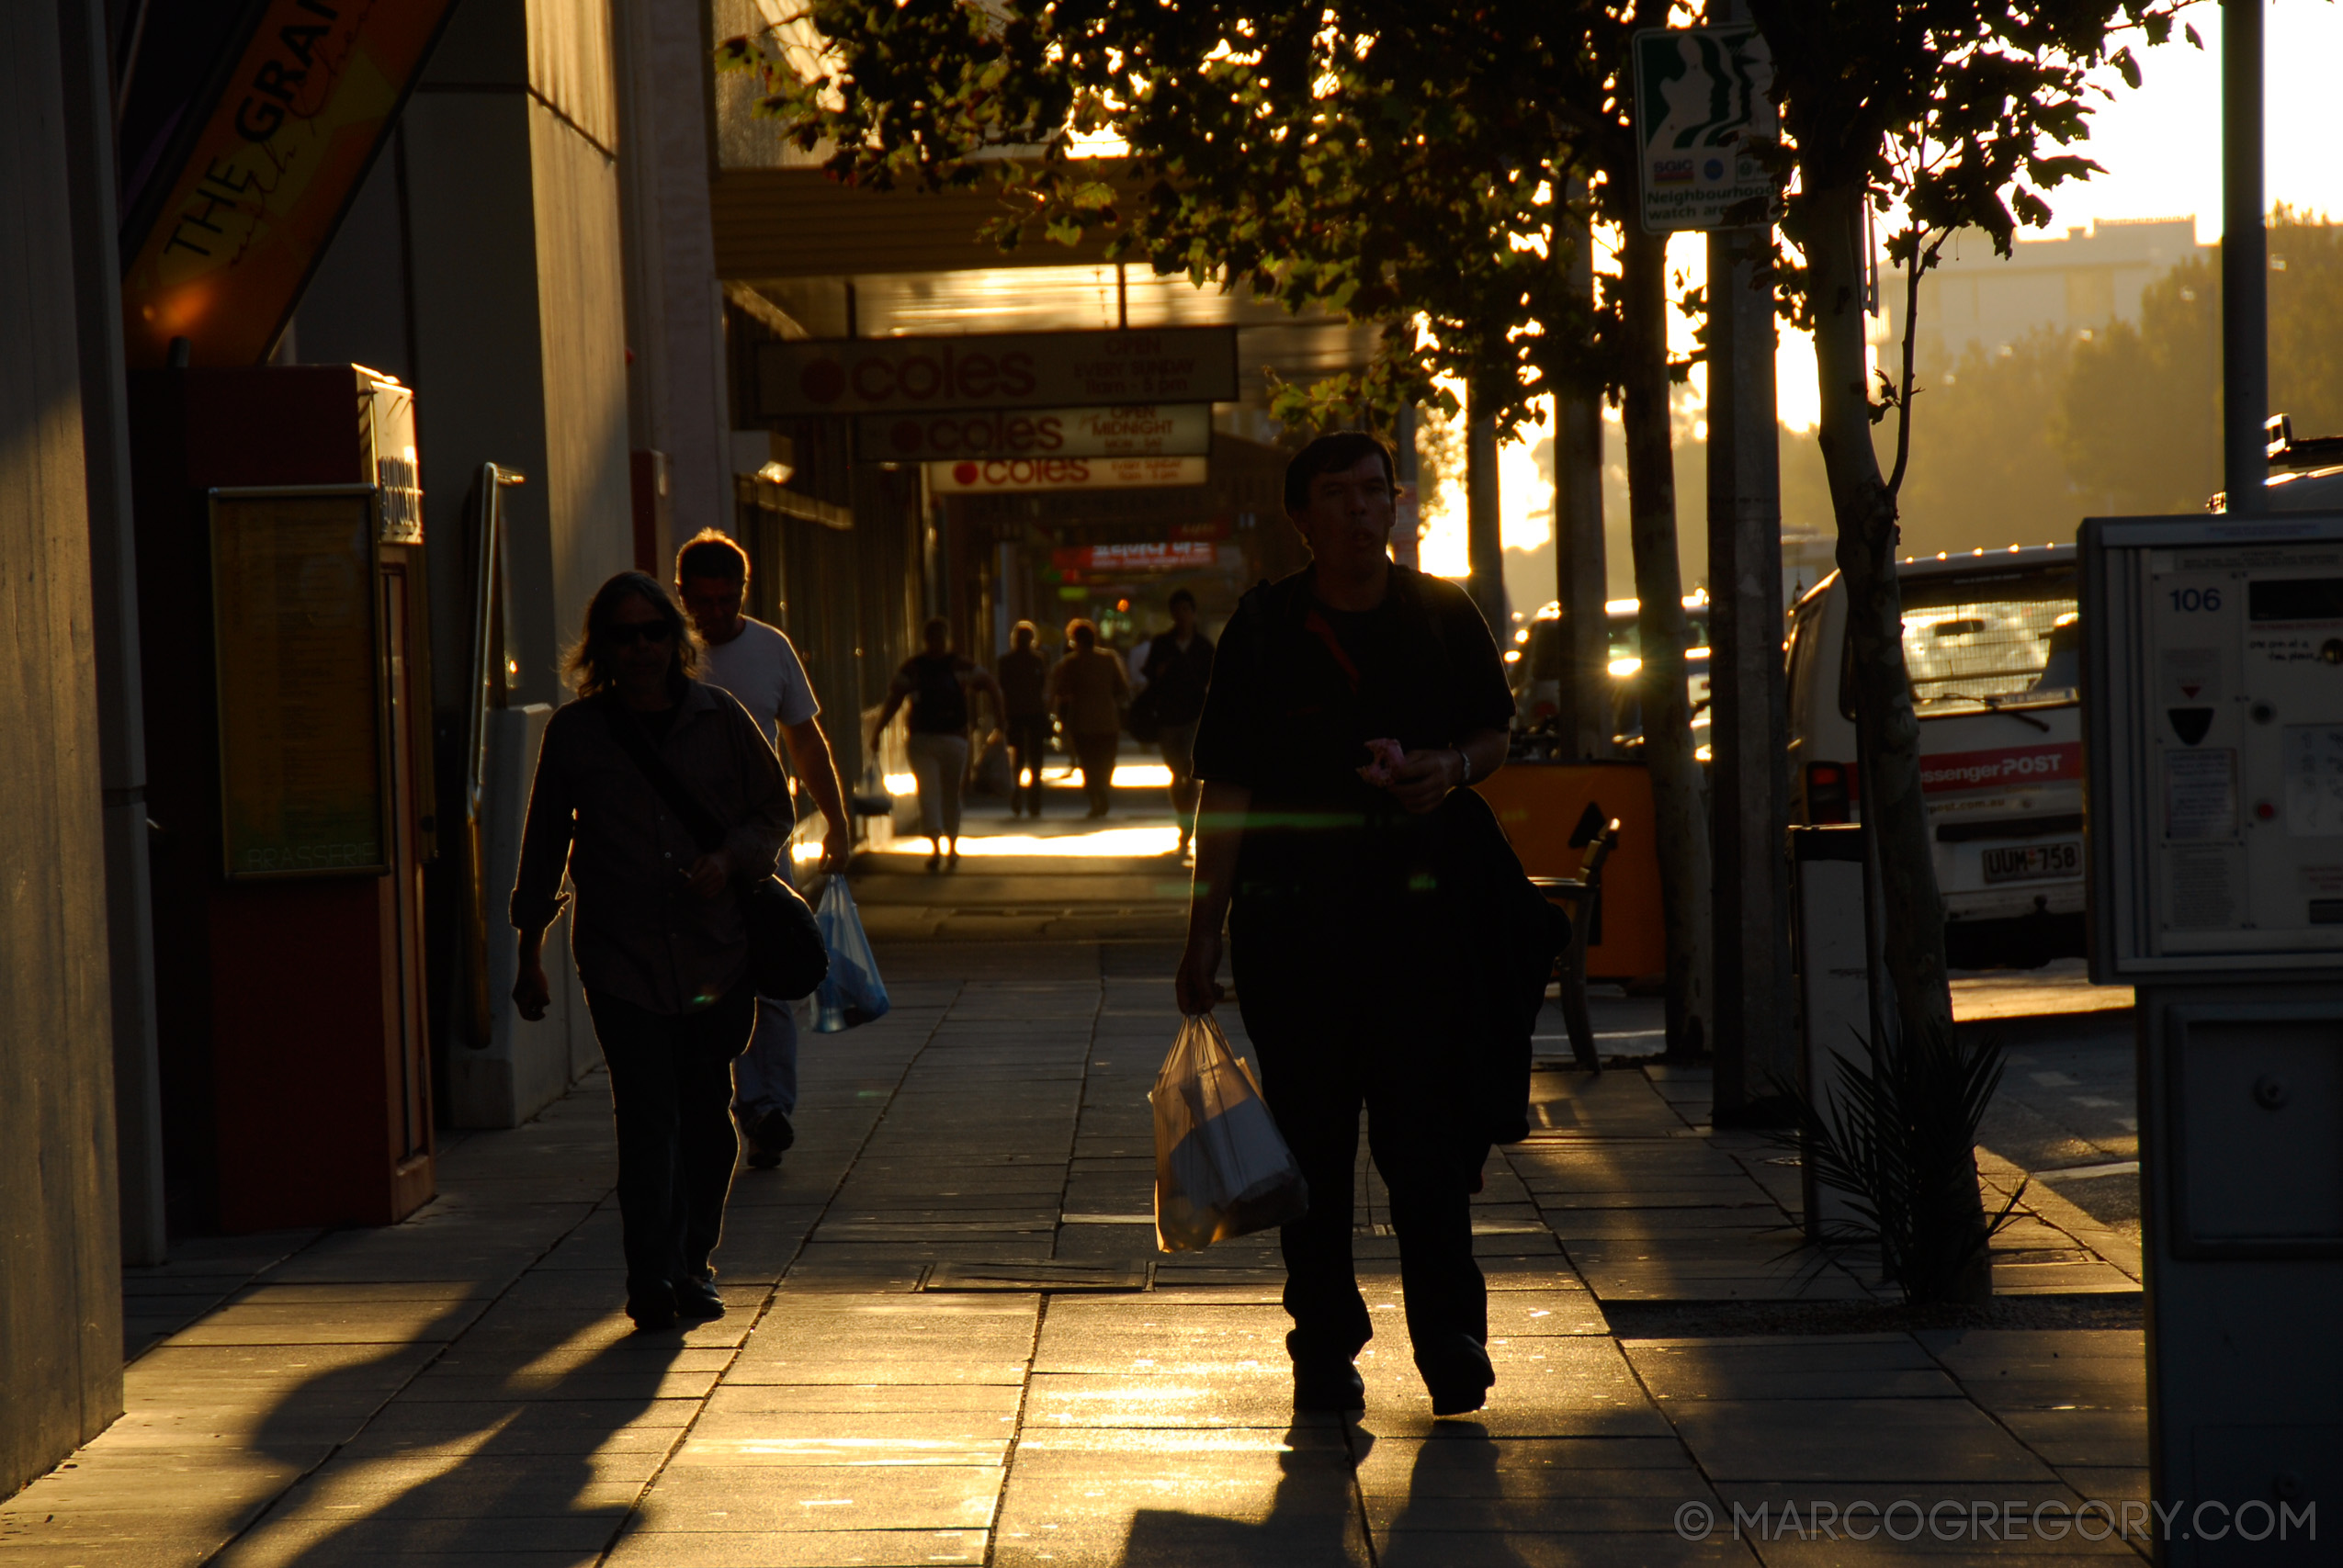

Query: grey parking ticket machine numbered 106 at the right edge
[{"left": 2080, "top": 513, "right": 2343, "bottom": 1565}]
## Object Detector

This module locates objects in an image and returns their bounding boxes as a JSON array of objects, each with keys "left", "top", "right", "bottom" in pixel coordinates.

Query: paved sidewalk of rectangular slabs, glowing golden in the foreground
[{"left": 0, "top": 923, "right": 2146, "bottom": 1568}]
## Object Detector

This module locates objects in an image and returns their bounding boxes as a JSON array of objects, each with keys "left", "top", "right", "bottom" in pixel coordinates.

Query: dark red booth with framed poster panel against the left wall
[{"left": 131, "top": 366, "right": 436, "bottom": 1231}]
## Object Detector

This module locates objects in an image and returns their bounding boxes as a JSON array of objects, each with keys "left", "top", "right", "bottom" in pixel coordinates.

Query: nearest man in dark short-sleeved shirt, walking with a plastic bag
[{"left": 1176, "top": 431, "right": 1525, "bottom": 1416}]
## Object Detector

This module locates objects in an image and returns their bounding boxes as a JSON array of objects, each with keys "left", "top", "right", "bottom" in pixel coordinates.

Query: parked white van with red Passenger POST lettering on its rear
[{"left": 1790, "top": 544, "right": 2083, "bottom": 968}]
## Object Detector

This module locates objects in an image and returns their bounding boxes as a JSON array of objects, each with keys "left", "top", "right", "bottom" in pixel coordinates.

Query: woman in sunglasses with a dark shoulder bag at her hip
[{"left": 513, "top": 572, "right": 789, "bottom": 1329}]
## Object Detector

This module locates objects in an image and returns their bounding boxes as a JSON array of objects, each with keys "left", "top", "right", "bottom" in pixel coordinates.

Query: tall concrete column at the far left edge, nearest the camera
[{"left": 0, "top": 5, "right": 122, "bottom": 1495}]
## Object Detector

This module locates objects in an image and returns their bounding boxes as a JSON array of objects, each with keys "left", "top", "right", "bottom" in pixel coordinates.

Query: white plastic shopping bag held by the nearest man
[{"left": 1149, "top": 1012, "right": 1309, "bottom": 1252}]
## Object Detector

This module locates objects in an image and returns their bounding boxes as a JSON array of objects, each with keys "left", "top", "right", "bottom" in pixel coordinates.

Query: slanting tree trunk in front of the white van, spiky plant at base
[{"left": 1805, "top": 183, "right": 1992, "bottom": 1301}]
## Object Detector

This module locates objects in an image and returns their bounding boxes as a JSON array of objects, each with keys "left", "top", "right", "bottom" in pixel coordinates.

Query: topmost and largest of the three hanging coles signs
[{"left": 757, "top": 326, "right": 1237, "bottom": 420}]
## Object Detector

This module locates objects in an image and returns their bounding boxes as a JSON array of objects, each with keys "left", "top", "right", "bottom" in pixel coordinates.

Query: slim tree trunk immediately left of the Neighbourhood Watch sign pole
[{"left": 1619, "top": 220, "right": 1715, "bottom": 1057}]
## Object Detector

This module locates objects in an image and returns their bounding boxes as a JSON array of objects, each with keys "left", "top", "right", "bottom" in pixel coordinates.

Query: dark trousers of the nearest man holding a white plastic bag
[{"left": 1237, "top": 947, "right": 1488, "bottom": 1381}]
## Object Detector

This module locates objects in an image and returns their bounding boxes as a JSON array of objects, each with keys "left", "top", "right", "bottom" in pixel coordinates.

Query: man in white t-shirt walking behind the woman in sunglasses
[{"left": 674, "top": 527, "right": 853, "bottom": 1169}]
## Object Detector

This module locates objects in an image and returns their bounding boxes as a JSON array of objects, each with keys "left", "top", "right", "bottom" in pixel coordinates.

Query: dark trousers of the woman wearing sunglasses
[{"left": 586, "top": 982, "right": 757, "bottom": 1296}]
